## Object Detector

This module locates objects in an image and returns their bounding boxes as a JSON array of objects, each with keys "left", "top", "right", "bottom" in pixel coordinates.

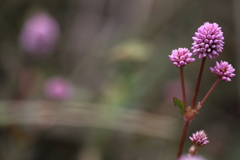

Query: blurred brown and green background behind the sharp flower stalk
[{"left": 0, "top": 0, "right": 240, "bottom": 160}]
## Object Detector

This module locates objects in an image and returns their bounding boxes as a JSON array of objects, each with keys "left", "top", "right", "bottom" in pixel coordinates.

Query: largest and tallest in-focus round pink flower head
[{"left": 191, "top": 22, "right": 224, "bottom": 59}]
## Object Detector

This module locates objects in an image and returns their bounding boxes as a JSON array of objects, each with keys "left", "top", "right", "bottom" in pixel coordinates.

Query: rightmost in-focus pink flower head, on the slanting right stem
[{"left": 210, "top": 61, "right": 236, "bottom": 82}]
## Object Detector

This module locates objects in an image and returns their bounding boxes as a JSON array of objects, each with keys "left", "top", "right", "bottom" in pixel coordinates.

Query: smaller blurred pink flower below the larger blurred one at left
[{"left": 44, "top": 77, "right": 73, "bottom": 100}]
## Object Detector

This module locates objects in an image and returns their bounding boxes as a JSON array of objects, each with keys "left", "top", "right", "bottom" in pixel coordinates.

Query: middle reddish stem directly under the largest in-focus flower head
[{"left": 191, "top": 57, "right": 206, "bottom": 109}]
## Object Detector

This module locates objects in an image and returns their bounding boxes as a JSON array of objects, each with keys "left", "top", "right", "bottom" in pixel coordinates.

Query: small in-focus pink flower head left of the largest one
[{"left": 168, "top": 48, "right": 195, "bottom": 68}]
